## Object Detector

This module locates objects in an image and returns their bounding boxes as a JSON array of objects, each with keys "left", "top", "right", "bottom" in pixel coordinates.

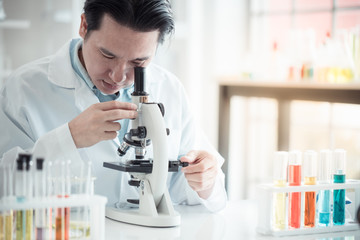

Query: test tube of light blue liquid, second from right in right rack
[{"left": 318, "top": 149, "right": 331, "bottom": 227}]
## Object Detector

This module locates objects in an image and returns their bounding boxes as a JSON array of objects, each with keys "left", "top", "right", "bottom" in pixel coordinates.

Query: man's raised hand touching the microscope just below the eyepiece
[{"left": 69, "top": 101, "right": 137, "bottom": 148}]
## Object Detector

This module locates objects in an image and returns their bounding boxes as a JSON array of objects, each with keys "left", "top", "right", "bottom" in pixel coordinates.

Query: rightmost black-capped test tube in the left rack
[{"left": 35, "top": 158, "right": 47, "bottom": 240}]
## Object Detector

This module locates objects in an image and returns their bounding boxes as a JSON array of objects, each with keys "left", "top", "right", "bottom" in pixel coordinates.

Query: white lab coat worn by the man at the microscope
[{"left": 0, "top": 39, "right": 226, "bottom": 211}]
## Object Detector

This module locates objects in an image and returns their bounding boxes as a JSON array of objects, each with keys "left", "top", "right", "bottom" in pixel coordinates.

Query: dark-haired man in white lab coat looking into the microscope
[{"left": 0, "top": 0, "right": 226, "bottom": 211}]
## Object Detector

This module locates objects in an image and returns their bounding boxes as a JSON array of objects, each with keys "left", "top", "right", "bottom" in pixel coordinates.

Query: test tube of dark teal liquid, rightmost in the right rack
[{"left": 333, "top": 149, "right": 346, "bottom": 225}]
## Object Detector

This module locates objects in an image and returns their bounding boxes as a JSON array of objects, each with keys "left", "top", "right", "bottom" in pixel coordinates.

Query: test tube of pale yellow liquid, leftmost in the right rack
[{"left": 273, "top": 151, "right": 288, "bottom": 230}]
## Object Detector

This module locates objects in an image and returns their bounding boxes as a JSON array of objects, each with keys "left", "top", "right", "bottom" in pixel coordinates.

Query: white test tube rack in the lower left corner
[{"left": 0, "top": 194, "right": 107, "bottom": 240}]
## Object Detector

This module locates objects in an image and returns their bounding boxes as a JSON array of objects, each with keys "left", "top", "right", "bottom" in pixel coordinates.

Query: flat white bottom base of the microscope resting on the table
[{"left": 105, "top": 207, "right": 181, "bottom": 227}]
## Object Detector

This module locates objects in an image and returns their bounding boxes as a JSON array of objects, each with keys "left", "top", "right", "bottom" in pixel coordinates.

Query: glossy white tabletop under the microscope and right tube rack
[{"left": 105, "top": 201, "right": 360, "bottom": 240}]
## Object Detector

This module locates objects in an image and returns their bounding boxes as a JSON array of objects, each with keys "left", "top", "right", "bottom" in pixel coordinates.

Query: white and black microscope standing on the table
[{"left": 103, "top": 67, "right": 188, "bottom": 227}]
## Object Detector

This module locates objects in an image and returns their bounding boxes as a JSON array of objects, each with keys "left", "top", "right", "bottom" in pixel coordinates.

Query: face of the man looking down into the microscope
[{"left": 79, "top": 14, "right": 159, "bottom": 94}]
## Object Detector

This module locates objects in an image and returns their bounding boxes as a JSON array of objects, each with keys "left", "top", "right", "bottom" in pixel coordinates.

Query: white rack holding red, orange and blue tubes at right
[{"left": 256, "top": 180, "right": 360, "bottom": 237}]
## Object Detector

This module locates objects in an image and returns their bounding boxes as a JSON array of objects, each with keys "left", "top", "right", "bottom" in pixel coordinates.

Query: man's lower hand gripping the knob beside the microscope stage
[{"left": 180, "top": 151, "right": 218, "bottom": 199}]
